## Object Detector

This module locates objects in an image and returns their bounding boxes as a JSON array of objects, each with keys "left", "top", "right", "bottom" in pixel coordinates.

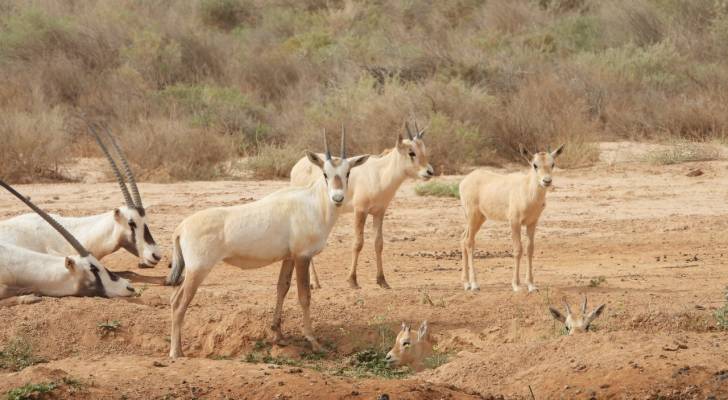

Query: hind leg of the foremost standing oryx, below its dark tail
[{"left": 169, "top": 264, "right": 212, "bottom": 358}]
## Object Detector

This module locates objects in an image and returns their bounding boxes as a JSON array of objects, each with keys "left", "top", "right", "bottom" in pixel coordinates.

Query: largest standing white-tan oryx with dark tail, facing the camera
[{"left": 167, "top": 132, "right": 369, "bottom": 357}]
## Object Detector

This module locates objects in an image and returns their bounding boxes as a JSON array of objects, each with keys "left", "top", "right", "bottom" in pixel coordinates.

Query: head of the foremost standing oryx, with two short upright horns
[{"left": 306, "top": 126, "right": 369, "bottom": 207}]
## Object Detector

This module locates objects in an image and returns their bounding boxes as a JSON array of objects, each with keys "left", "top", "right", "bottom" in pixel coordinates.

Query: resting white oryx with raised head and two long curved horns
[{"left": 0, "top": 124, "right": 161, "bottom": 268}]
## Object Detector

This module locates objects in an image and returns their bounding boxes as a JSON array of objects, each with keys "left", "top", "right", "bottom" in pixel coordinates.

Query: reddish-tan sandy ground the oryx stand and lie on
[{"left": 0, "top": 146, "right": 728, "bottom": 399}]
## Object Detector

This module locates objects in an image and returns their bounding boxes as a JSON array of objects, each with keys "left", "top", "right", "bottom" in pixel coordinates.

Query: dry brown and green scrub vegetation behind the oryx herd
[{"left": 0, "top": 0, "right": 728, "bottom": 181}]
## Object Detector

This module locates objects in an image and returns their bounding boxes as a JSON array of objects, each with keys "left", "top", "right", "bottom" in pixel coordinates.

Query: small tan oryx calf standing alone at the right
[{"left": 460, "top": 145, "right": 564, "bottom": 292}]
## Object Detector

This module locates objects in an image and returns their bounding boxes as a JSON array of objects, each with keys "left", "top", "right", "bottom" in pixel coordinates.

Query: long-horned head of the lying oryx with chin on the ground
[{"left": 0, "top": 180, "right": 136, "bottom": 297}]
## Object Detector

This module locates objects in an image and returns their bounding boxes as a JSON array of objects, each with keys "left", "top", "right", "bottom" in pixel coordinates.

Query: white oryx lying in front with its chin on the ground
[{"left": 0, "top": 181, "right": 135, "bottom": 306}]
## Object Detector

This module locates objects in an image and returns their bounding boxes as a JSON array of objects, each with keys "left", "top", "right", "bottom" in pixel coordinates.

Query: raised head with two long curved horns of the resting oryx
[{"left": 88, "top": 120, "right": 162, "bottom": 268}]
